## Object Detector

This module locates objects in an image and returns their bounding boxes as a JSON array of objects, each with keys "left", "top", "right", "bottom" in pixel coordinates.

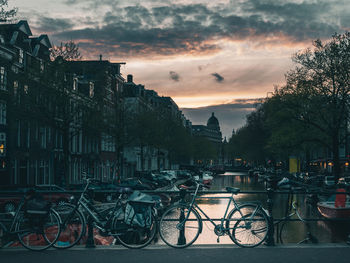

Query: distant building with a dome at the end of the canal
[{"left": 192, "top": 112, "right": 222, "bottom": 143}]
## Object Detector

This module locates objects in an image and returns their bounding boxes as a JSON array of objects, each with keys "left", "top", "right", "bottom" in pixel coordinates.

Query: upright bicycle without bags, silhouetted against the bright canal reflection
[{"left": 159, "top": 182, "right": 269, "bottom": 248}]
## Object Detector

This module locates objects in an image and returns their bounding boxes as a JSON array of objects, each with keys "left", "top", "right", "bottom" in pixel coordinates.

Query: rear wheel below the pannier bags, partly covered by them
[{"left": 115, "top": 215, "right": 158, "bottom": 248}]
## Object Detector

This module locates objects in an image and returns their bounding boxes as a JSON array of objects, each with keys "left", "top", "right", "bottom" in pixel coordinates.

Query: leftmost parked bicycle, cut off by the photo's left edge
[{"left": 0, "top": 191, "right": 61, "bottom": 251}]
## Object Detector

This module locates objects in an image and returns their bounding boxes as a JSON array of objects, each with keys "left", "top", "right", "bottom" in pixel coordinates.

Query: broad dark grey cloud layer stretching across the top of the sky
[{"left": 40, "top": 0, "right": 346, "bottom": 58}]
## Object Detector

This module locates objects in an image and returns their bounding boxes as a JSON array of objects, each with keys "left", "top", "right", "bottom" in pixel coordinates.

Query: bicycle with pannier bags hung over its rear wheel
[{"left": 54, "top": 174, "right": 157, "bottom": 249}]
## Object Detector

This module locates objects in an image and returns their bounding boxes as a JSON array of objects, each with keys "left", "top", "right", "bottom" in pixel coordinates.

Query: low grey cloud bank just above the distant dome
[{"left": 181, "top": 102, "right": 256, "bottom": 139}]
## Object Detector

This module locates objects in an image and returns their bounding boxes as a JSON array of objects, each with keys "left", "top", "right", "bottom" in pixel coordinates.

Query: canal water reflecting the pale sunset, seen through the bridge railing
[{"left": 159, "top": 173, "right": 350, "bottom": 244}]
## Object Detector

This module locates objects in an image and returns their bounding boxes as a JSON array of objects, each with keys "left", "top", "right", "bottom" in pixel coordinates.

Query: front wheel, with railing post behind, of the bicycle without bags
[{"left": 159, "top": 205, "right": 202, "bottom": 248}]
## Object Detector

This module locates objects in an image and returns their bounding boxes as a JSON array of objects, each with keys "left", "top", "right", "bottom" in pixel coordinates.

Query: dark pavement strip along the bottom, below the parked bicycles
[{"left": 0, "top": 244, "right": 350, "bottom": 263}]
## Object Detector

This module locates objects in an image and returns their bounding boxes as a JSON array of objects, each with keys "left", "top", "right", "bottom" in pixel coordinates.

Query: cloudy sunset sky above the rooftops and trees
[{"left": 9, "top": 0, "right": 350, "bottom": 137}]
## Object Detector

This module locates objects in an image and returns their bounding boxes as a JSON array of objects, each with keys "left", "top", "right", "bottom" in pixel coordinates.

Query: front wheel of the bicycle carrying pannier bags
[{"left": 53, "top": 203, "right": 86, "bottom": 249}]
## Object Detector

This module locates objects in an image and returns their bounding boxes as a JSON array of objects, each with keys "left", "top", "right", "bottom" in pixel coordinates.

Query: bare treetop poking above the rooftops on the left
[{"left": 50, "top": 40, "right": 82, "bottom": 61}]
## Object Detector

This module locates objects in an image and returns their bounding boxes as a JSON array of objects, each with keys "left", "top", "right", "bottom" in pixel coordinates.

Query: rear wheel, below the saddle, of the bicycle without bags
[{"left": 229, "top": 210, "right": 269, "bottom": 247}]
